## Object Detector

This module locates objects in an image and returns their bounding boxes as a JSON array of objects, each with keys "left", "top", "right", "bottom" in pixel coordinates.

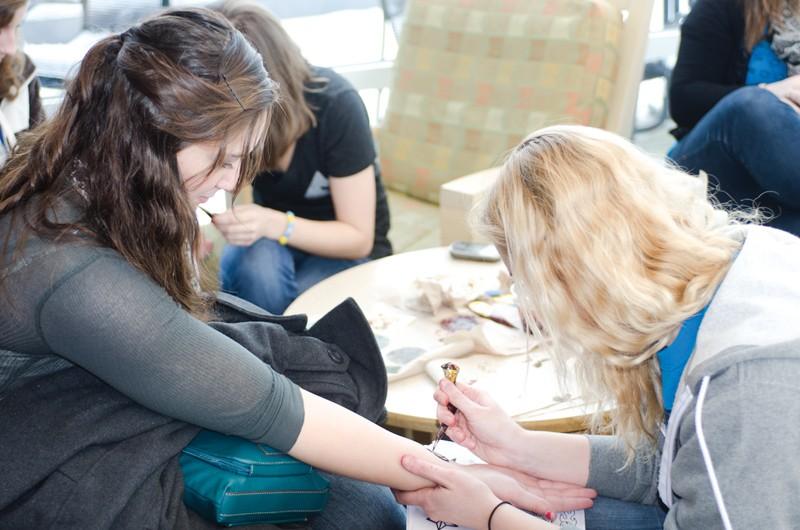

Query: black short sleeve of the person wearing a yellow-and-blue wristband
[{"left": 319, "top": 89, "right": 375, "bottom": 177}]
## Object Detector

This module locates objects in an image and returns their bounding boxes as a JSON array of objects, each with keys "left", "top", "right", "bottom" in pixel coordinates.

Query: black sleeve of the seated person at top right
[{"left": 669, "top": 0, "right": 743, "bottom": 129}]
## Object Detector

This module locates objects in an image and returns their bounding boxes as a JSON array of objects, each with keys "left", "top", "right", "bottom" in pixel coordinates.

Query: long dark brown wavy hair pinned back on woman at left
[{"left": 0, "top": 9, "right": 276, "bottom": 313}]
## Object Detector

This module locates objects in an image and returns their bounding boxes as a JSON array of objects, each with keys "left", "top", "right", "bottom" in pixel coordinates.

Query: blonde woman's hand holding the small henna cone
[{"left": 433, "top": 379, "right": 524, "bottom": 467}]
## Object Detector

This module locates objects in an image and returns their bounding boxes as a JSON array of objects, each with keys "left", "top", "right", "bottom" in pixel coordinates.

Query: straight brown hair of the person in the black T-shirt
[{"left": 213, "top": 0, "right": 325, "bottom": 169}]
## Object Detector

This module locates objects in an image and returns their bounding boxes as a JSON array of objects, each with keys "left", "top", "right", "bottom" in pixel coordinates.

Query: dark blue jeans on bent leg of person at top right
[{"left": 669, "top": 87, "right": 800, "bottom": 235}]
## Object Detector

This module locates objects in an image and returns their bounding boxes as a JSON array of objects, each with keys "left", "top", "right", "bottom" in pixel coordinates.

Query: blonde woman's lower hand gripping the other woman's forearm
[{"left": 395, "top": 455, "right": 500, "bottom": 528}]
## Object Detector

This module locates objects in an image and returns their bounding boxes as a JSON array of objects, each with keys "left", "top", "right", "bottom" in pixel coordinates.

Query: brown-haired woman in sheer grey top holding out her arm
[{"left": 0, "top": 9, "right": 591, "bottom": 530}]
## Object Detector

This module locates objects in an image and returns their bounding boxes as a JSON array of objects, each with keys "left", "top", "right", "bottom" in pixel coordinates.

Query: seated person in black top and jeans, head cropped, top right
[{"left": 669, "top": 0, "right": 800, "bottom": 235}]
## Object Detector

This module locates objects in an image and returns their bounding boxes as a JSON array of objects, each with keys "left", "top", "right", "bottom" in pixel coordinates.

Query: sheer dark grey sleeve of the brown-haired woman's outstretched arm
[{"left": 38, "top": 256, "right": 304, "bottom": 451}]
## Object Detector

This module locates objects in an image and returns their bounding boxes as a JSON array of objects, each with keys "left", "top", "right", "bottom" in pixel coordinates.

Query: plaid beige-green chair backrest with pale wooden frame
[{"left": 378, "top": 0, "right": 653, "bottom": 202}]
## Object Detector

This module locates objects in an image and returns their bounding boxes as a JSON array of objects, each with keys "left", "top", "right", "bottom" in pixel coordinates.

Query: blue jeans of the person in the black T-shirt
[{"left": 219, "top": 238, "right": 367, "bottom": 315}]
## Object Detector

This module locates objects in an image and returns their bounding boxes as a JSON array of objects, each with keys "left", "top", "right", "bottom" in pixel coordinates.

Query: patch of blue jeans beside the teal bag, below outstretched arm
[{"left": 311, "top": 473, "right": 406, "bottom": 530}]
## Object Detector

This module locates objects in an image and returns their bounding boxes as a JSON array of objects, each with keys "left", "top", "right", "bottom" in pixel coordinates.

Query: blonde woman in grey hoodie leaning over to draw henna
[{"left": 399, "top": 126, "right": 800, "bottom": 530}]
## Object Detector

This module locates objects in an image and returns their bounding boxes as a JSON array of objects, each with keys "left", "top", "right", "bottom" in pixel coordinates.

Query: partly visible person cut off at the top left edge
[{"left": 0, "top": 0, "right": 44, "bottom": 165}]
